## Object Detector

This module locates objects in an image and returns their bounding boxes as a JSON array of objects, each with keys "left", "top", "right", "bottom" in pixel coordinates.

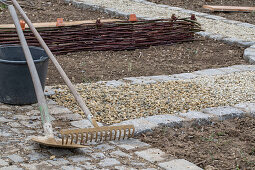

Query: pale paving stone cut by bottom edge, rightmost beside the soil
[{"left": 158, "top": 159, "right": 202, "bottom": 170}]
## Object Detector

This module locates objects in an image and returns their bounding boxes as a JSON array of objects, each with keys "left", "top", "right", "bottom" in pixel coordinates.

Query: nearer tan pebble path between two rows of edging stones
[{"left": 51, "top": 70, "right": 255, "bottom": 124}]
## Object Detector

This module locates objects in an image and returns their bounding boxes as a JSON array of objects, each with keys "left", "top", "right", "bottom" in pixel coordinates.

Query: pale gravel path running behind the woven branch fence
[{"left": 70, "top": 0, "right": 255, "bottom": 41}]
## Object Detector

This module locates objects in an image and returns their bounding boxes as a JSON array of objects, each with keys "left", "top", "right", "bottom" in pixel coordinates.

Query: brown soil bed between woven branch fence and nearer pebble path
[{"left": 47, "top": 37, "right": 247, "bottom": 85}]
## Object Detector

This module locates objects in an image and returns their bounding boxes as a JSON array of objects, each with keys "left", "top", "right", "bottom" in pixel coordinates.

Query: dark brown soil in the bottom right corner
[{"left": 140, "top": 117, "right": 255, "bottom": 170}]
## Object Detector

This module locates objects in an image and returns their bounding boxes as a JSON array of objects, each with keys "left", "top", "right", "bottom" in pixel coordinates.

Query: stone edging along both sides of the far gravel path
[{"left": 65, "top": 0, "right": 255, "bottom": 64}]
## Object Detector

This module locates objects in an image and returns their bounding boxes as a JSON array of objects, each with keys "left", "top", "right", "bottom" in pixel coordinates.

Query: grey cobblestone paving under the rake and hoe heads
[{"left": 0, "top": 101, "right": 203, "bottom": 170}]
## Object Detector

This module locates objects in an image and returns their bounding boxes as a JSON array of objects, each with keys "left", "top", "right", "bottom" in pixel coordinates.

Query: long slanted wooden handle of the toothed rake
[{"left": 12, "top": 0, "right": 98, "bottom": 127}]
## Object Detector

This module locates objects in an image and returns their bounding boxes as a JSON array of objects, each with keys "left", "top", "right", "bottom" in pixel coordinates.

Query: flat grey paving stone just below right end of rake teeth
[{"left": 110, "top": 139, "right": 150, "bottom": 150}]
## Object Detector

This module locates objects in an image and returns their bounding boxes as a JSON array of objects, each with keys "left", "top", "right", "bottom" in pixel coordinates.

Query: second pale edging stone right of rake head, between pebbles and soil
[{"left": 145, "top": 114, "right": 184, "bottom": 126}]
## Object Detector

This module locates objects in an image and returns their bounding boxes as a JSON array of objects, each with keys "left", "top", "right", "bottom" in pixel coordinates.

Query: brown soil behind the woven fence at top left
[{"left": 0, "top": 0, "right": 120, "bottom": 24}]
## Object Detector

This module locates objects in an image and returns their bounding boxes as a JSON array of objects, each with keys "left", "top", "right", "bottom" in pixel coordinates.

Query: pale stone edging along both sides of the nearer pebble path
[{"left": 45, "top": 65, "right": 255, "bottom": 135}]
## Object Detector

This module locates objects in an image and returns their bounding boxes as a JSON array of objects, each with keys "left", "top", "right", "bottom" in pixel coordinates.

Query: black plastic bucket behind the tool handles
[{"left": 0, "top": 46, "right": 49, "bottom": 105}]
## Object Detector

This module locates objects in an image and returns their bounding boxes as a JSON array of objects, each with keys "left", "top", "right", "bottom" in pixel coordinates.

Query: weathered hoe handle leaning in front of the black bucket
[{"left": 8, "top": 5, "right": 53, "bottom": 136}]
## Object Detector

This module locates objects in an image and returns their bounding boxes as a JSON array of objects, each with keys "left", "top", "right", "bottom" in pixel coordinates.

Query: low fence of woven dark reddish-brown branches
[{"left": 0, "top": 15, "right": 201, "bottom": 54}]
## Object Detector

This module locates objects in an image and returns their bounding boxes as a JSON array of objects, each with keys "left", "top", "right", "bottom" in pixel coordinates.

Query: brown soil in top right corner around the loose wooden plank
[{"left": 148, "top": 0, "right": 255, "bottom": 24}]
